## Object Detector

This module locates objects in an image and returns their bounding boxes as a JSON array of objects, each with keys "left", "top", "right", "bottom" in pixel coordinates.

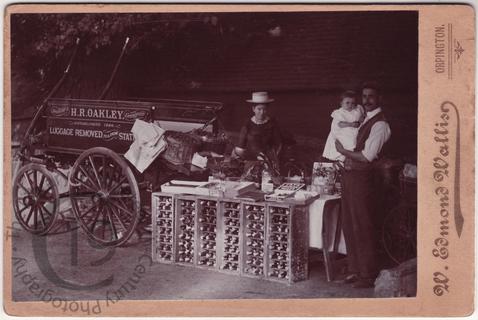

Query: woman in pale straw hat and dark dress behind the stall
[{"left": 233, "top": 92, "right": 282, "bottom": 160}]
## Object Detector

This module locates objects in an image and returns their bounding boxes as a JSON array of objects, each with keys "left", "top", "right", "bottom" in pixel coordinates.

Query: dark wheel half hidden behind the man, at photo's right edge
[{"left": 382, "top": 204, "right": 417, "bottom": 264}]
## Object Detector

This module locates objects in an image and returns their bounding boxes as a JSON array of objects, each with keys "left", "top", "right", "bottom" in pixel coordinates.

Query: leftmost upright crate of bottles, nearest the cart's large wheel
[{"left": 151, "top": 192, "right": 175, "bottom": 263}]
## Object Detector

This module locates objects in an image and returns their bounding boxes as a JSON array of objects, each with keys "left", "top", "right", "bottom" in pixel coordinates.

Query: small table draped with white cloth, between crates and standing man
[{"left": 309, "top": 194, "right": 346, "bottom": 281}]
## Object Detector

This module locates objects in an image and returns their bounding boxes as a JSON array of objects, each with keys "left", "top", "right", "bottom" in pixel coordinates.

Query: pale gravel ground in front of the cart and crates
[{"left": 12, "top": 218, "right": 373, "bottom": 301}]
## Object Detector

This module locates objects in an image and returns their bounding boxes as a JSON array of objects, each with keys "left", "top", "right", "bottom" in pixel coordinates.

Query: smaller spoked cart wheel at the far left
[{"left": 13, "top": 164, "right": 60, "bottom": 235}]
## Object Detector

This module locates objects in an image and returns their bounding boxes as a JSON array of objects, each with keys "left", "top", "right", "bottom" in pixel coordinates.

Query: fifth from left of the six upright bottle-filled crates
[{"left": 241, "top": 202, "right": 267, "bottom": 278}]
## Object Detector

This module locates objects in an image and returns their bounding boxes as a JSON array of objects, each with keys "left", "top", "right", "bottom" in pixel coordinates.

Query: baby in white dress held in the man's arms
[{"left": 322, "top": 91, "right": 365, "bottom": 161}]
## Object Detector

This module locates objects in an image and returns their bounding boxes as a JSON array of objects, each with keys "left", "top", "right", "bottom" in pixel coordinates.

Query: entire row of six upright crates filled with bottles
[{"left": 153, "top": 193, "right": 309, "bottom": 284}]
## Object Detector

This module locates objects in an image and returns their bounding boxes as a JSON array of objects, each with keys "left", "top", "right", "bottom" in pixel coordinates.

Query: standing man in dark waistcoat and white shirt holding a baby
[{"left": 335, "top": 82, "right": 391, "bottom": 288}]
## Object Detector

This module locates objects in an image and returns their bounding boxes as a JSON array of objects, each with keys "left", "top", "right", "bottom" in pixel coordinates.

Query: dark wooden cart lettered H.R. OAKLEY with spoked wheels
[{"left": 13, "top": 98, "right": 222, "bottom": 246}]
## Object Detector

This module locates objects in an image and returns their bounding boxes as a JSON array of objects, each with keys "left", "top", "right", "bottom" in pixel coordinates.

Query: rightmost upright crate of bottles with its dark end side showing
[{"left": 266, "top": 203, "right": 309, "bottom": 284}]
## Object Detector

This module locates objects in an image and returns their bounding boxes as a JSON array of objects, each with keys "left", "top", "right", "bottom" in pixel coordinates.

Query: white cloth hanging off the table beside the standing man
[{"left": 309, "top": 195, "right": 346, "bottom": 254}]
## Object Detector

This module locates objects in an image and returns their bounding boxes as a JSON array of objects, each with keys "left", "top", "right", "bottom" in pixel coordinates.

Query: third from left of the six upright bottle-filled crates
[{"left": 196, "top": 197, "right": 221, "bottom": 269}]
